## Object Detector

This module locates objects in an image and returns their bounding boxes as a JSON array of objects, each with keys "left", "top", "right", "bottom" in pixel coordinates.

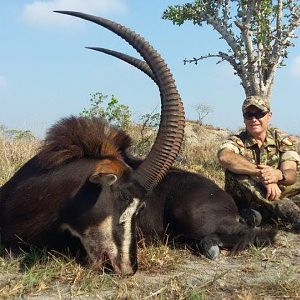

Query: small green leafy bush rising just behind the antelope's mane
[{"left": 80, "top": 92, "right": 131, "bottom": 130}]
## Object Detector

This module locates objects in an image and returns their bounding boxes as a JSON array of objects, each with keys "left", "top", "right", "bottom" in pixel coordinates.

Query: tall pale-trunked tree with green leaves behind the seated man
[{"left": 163, "top": 0, "right": 300, "bottom": 99}]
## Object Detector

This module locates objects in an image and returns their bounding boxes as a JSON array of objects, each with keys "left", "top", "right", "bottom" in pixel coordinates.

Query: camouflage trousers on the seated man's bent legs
[{"left": 225, "top": 171, "right": 300, "bottom": 215}]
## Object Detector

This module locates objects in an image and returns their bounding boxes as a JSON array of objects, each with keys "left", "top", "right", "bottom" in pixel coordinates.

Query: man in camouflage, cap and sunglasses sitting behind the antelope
[{"left": 218, "top": 96, "right": 300, "bottom": 233}]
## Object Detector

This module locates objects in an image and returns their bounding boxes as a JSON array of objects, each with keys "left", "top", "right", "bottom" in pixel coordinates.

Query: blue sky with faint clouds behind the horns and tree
[{"left": 0, "top": 0, "right": 300, "bottom": 136}]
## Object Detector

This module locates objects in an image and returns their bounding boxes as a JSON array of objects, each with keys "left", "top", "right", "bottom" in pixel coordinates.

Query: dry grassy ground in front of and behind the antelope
[{"left": 0, "top": 125, "right": 300, "bottom": 299}]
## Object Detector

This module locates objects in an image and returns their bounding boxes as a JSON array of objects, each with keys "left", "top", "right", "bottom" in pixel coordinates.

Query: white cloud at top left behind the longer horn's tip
[{"left": 23, "top": 0, "right": 126, "bottom": 25}]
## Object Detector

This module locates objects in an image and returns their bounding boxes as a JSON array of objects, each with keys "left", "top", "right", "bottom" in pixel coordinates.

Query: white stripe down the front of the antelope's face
[{"left": 119, "top": 198, "right": 140, "bottom": 266}]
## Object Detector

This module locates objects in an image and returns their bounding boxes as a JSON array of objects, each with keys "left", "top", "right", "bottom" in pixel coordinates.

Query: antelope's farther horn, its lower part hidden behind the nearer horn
[{"left": 86, "top": 47, "right": 156, "bottom": 83}]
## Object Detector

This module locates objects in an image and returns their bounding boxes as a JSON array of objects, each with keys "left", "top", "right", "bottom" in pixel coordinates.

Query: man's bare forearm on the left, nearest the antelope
[{"left": 218, "top": 148, "right": 260, "bottom": 176}]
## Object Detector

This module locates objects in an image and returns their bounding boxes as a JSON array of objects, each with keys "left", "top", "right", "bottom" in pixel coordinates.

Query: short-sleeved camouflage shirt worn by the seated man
[{"left": 219, "top": 127, "right": 300, "bottom": 168}]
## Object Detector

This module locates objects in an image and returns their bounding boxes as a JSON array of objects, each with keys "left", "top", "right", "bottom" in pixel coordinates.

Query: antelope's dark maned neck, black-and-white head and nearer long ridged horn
[{"left": 0, "top": 11, "right": 184, "bottom": 274}]
